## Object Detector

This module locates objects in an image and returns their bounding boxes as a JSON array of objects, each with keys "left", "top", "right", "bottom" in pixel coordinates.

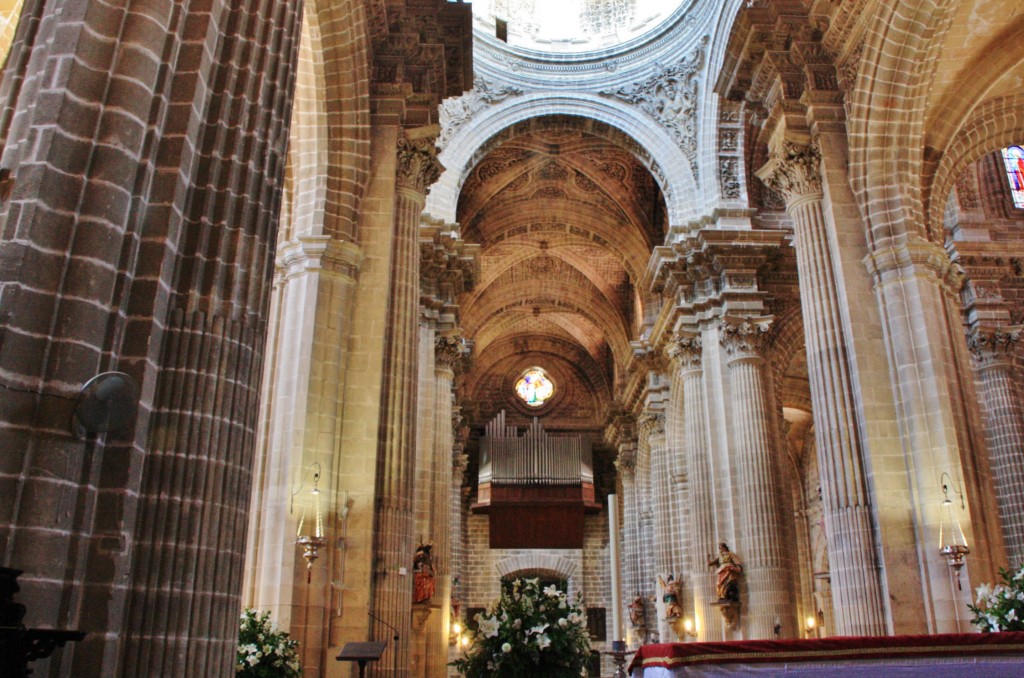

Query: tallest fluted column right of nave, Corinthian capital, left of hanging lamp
[{"left": 758, "top": 141, "right": 886, "bottom": 635}]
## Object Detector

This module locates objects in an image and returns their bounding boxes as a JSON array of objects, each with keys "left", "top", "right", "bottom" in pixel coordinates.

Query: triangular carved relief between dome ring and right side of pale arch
[{"left": 600, "top": 37, "right": 708, "bottom": 178}]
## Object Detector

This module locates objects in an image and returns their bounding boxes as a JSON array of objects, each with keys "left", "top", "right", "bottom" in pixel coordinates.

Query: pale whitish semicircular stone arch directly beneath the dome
[{"left": 425, "top": 92, "right": 698, "bottom": 225}]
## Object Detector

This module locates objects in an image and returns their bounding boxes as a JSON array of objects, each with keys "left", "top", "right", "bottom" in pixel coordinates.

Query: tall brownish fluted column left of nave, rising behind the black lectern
[{"left": 370, "top": 128, "right": 440, "bottom": 676}]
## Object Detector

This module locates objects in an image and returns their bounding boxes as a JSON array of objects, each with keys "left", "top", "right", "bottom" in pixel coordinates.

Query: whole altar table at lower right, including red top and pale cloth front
[{"left": 630, "top": 633, "right": 1024, "bottom": 678}]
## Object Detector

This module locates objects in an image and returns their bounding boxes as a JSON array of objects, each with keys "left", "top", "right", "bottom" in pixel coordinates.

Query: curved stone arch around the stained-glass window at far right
[{"left": 928, "top": 93, "right": 1024, "bottom": 228}]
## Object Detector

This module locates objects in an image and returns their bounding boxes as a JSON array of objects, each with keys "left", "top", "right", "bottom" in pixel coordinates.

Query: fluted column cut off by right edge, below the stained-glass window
[{"left": 968, "top": 326, "right": 1024, "bottom": 567}]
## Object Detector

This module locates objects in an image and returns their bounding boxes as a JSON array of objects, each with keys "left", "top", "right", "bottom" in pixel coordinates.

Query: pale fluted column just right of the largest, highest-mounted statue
[{"left": 715, "top": 317, "right": 796, "bottom": 638}]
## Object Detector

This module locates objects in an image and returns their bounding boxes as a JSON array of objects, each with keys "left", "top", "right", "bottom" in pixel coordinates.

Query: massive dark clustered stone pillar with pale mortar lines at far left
[{"left": 0, "top": 0, "right": 301, "bottom": 676}]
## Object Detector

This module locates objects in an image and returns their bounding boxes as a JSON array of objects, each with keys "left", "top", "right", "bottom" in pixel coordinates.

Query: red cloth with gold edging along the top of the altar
[{"left": 630, "top": 632, "right": 1024, "bottom": 675}]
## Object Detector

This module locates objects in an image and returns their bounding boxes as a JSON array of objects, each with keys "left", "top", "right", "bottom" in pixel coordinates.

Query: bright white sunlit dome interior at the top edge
[{"left": 473, "top": 0, "right": 688, "bottom": 54}]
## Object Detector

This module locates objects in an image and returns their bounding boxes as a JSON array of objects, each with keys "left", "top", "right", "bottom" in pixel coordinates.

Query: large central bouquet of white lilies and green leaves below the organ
[{"left": 452, "top": 579, "right": 590, "bottom": 678}]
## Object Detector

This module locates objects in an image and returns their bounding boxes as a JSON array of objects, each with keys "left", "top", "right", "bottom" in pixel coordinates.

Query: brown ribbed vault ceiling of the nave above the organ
[{"left": 458, "top": 117, "right": 665, "bottom": 427}]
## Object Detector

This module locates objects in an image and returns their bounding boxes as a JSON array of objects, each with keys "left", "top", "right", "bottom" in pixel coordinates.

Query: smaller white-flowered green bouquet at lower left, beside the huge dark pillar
[{"left": 234, "top": 609, "right": 302, "bottom": 678}]
